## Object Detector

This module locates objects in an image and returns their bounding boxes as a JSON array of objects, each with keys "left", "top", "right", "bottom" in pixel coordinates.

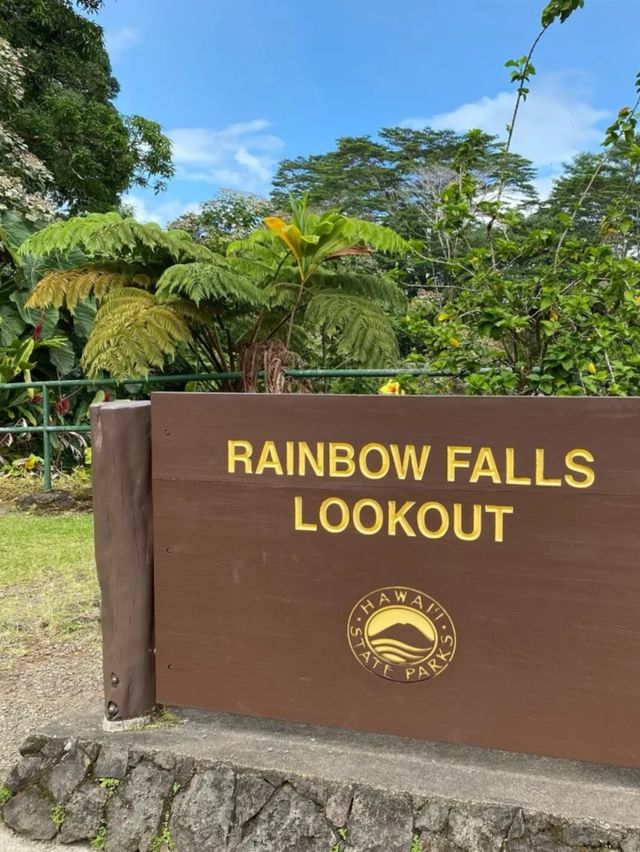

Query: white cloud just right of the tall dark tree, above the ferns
[{"left": 168, "top": 119, "right": 284, "bottom": 193}]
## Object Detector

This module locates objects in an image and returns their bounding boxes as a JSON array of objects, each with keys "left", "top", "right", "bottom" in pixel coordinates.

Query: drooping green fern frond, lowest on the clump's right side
[{"left": 304, "top": 290, "right": 399, "bottom": 367}]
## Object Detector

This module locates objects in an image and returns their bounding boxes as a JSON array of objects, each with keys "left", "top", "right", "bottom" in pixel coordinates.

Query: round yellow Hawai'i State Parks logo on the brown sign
[{"left": 347, "top": 586, "right": 456, "bottom": 683}]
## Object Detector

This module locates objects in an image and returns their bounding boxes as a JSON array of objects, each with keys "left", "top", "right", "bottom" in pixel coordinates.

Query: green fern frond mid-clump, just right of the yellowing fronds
[{"left": 156, "top": 264, "right": 264, "bottom": 308}]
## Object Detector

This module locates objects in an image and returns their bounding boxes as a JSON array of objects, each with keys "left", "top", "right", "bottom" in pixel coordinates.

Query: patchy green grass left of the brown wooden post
[{"left": 0, "top": 512, "right": 99, "bottom": 669}]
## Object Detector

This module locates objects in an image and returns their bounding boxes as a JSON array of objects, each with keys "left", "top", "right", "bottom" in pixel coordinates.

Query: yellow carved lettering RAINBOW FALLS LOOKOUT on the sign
[{"left": 227, "top": 439, "right": 596, "bottom": 543}]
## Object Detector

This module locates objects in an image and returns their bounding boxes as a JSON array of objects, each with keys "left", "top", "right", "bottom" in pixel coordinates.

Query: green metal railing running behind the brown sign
[{"left": 0, "top": 367, "right": 457, "bottom": 491}]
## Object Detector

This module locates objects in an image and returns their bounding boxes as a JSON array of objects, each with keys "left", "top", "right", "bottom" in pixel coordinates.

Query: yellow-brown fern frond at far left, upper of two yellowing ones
[{"left": 25, "top": 266, "right": 136, "bottom": 312}]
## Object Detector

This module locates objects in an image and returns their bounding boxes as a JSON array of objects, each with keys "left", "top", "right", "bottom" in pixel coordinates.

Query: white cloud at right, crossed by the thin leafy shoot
[{"left": 402, "top": 73, "right": 609, "bottom": 195}]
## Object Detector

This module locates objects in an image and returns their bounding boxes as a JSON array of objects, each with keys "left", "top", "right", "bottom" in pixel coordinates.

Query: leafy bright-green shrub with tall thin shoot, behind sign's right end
[{"left": 390, "top": 0, "right": 640, "bottom": 395}]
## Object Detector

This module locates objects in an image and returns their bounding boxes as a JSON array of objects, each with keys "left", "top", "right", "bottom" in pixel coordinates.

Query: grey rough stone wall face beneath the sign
[{"left": 0, "top": 735, "right": 640, "bottom": 852}]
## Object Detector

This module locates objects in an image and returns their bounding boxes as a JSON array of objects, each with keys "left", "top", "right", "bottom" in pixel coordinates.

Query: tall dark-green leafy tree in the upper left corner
[{"left": 0, "top": 0, "right": 173, "bottom": 212}]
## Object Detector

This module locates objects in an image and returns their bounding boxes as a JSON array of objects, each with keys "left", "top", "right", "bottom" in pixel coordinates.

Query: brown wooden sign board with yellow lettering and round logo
[{"left": 152, "top": 394, "right": 640, "bottom": 766}]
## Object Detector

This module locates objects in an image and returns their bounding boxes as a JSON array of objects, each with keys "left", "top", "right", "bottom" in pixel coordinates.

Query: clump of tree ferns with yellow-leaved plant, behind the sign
[{"left": 19, "top": 199, "right": 410, "bottom": 387}]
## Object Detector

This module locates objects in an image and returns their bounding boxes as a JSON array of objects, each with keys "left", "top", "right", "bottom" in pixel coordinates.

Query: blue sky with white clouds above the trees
[{"left": 98, "top": 0, "right": 640, "bottom": 221}]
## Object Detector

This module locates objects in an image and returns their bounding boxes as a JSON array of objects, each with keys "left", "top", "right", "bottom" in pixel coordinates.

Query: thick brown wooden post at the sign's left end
[{"left": 91, "top": 401, "right": 155, "bottom": 730}]
